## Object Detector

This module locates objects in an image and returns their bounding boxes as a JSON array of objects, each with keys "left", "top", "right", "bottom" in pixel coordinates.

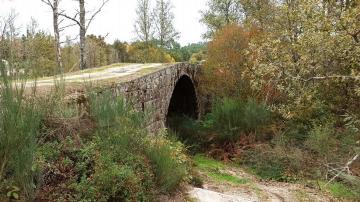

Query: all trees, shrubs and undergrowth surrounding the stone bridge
[{"left": 0, "top": 0, "right": 360, "bottom": 201}]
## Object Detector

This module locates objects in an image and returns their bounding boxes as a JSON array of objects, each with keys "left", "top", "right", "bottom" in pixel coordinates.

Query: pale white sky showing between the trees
[{"left": 0, "top": 0, "right": 207, "bottom": 45}]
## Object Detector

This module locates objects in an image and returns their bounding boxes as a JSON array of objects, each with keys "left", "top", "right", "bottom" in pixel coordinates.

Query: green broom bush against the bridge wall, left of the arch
[{"left": 68, "top": 92, "right": 189, "bottom": 201}]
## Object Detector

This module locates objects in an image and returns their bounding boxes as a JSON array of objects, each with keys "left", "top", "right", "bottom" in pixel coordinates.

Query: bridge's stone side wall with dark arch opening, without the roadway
[{"left": 116, "top": 63, "right": 200, "bottom": 131}]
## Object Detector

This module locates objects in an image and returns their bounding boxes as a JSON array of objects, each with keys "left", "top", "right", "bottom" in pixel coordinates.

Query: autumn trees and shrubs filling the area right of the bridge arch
[{"left": 179, "top": 0, "right": 360, "bottom": 200}]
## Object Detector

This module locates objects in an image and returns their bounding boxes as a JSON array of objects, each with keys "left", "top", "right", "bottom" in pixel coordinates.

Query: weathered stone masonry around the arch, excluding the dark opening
[{"left": 116, "top": 63, "right": 200, "bottom": 132}]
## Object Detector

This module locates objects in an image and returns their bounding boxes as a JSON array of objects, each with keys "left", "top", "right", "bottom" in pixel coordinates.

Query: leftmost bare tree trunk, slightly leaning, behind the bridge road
[{"left": 53, "top": 0, "right": 64, "bottom": 74}]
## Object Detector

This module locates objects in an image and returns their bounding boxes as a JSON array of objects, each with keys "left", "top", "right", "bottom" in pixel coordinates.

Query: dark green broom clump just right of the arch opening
[{"left": 204, "top": 98, "right": 270, "bottom": 142}]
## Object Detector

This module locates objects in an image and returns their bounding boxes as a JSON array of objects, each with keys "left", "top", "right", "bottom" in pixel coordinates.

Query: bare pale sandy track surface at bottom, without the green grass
[{"left": 188, "top": 168, "right": 336, "bottom": 202}]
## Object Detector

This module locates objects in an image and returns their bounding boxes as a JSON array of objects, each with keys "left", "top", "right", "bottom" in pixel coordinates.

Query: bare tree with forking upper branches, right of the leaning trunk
[{"left": 60, "top": 0, "right": 109, "bottom": 69}]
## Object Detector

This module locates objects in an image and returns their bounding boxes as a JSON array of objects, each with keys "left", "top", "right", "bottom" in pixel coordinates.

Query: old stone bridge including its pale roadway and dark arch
[{"left": 34, "top": 63, "right": 201, "bottom": 131}]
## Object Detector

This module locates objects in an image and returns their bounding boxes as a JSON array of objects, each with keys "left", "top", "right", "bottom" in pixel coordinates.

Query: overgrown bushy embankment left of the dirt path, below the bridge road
[{"left": 0, "top": 62, "right": 190, "bottom": 201}]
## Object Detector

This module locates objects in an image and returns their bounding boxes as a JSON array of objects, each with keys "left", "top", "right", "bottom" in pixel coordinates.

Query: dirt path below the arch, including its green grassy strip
[{"left": 188, "top": 156, "right": 336, "bottom": 202}]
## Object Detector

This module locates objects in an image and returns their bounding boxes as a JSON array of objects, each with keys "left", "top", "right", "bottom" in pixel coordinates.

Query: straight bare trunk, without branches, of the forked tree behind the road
[{"left": 79, "top": 0, "right": 86, "bottom": 69}]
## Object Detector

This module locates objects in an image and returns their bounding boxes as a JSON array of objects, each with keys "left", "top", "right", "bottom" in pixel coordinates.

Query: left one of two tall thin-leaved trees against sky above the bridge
[{"left": 134, "top": 0, "right": 154, "bottom": 44}]
